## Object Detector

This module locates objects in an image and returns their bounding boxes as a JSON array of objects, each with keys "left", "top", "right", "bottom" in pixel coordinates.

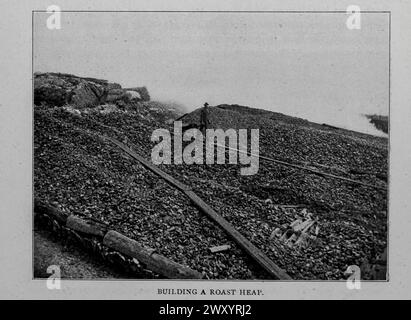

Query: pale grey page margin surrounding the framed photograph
[{"left": 0, "top": 0, "right": 411, "bottom": 299}]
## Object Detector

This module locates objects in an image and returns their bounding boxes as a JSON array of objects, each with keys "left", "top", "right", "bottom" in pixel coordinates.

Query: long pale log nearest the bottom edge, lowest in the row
[{"left": 103, "top": 230, "right": 202, "bottom": 279}]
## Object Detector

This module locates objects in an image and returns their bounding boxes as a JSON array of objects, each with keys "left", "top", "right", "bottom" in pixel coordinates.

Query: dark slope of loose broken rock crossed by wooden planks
[{"left": 34, "top": 73, "right": 388, "bottom": 279}]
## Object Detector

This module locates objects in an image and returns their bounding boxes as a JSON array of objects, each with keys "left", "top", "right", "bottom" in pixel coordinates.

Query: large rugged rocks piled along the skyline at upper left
[{"left": 34, "top": 73, "right": 150, "bottom": 109}]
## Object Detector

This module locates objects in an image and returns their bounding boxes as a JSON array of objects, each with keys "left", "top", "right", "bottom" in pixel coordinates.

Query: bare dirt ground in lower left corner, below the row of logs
[{"left": 33, "top": 230, "right": 128, "bottom": 280}]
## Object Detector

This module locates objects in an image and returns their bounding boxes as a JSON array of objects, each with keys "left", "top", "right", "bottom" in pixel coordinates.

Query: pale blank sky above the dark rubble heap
[{"left": 33, "top": 12, "right": 389, "bottom": 135}]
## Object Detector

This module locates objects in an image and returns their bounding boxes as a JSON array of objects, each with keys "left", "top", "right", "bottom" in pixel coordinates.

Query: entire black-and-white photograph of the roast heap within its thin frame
[{"left": 32, "top": 6, "right": 392, "bottom": 285}]
